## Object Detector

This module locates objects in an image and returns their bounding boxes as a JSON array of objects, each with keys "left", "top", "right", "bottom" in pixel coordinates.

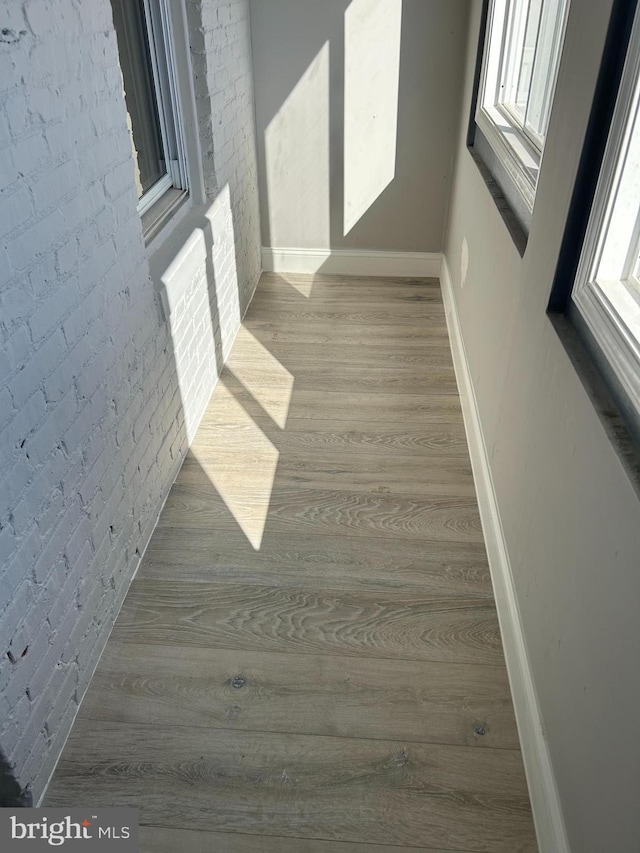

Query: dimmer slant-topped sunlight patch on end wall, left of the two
[{"left": 265, "top": 42, "right": 330, "bottom": 249}]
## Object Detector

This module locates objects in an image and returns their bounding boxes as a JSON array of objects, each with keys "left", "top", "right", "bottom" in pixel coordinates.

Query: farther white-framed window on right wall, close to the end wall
[{"left": 475, "top": 0, "right": 568, "bottom": 218}]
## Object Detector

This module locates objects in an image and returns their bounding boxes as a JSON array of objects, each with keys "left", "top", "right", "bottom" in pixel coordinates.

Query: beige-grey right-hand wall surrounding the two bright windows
[{"left": 445, "top": 0, "right": 640, "bottom": 853}]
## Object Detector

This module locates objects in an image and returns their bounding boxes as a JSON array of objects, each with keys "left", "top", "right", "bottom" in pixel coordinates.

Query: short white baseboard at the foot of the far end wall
[{"left": 262, "top": 246, "right": 442, "bottom": 278}]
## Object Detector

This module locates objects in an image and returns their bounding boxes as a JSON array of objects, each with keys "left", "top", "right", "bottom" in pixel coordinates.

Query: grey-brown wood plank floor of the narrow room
[{"left": 46, "top": 274, "right": 537, "bottom": 853}]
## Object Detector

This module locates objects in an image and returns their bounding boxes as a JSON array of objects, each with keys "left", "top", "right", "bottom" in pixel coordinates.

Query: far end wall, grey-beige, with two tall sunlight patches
[{"left": 251, "top": 0, "right": 468, "bottom": 252}]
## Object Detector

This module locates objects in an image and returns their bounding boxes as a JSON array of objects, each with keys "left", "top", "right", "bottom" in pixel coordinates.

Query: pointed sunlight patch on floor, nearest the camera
[{"left": 190, "top": 387, "right": 279, "bottom": 551}]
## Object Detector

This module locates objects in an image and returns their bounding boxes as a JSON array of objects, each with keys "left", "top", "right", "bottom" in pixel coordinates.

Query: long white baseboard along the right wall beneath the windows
[{"left": 440, "top": 257, "right": 570, "bottom": 853}]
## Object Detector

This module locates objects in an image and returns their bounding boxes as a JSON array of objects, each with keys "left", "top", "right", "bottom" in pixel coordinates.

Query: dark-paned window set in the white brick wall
[{"left": 111, "top": 0, "right": 187, "bottom": 233}]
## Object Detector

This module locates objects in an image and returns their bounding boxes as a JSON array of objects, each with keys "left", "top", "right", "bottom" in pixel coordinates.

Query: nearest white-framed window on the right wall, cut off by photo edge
[{"left": 568, "top": 5, "right": 640, "bottom": 437}]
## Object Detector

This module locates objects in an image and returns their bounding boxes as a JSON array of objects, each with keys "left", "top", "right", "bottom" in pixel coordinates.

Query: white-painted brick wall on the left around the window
[{"left": 0, "top": 0, "right": 259, "bottom": 800}]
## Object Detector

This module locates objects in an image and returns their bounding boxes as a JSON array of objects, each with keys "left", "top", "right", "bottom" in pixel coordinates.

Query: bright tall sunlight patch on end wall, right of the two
[{"left": 344, "top": 0, "right": 402, "bottom": 234}]
